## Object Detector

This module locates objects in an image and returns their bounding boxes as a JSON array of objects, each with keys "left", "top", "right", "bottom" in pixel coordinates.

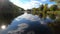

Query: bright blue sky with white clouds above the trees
[{"left": 9, "top": 0, "right": 55, "bottom": 10}]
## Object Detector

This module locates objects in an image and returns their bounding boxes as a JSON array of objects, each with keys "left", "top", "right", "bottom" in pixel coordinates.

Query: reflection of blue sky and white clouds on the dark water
[{"left": 0, "top": 13, "right": 52, "bottom": 34}]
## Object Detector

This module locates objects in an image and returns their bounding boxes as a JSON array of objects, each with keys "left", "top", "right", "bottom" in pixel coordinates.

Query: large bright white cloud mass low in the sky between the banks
[{"left": 10, "top": 0, "right": 42, "bottom": 10}]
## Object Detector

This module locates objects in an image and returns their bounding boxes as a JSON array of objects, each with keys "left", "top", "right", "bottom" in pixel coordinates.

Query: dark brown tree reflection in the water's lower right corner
[{"left": 48, "top": 19, "right": 60, "bottom": 34}]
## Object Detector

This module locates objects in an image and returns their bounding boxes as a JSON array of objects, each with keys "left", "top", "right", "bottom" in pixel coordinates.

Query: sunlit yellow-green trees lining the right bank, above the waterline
[{"left": 32, "top": 4, "right": 59, "bottom": 12}]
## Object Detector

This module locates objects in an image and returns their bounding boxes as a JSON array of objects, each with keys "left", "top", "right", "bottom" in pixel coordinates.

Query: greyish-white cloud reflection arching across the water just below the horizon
[{"left": 15, "top": 13, "right": 40, "bottom": 21}]
